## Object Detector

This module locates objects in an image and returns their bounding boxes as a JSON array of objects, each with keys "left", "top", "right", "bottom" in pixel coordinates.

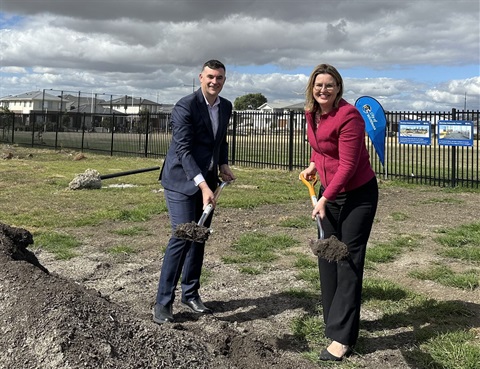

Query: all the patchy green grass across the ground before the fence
[{"left": 0, "top": 144, "right": 480, "bottom": 369}]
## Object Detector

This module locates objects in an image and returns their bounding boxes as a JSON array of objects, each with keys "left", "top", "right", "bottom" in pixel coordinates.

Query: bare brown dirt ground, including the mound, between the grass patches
[{"left": 0, "top": 186, "right": 480, "bottom": 369}]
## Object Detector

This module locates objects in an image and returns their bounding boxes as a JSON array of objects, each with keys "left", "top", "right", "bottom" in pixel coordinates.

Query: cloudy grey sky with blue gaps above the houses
[{"left": 0, "top": 0, "right": 480, "bottom": 111}]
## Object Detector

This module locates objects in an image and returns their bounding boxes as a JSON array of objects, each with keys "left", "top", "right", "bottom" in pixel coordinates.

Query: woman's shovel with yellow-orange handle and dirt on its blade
[{"left": 298, "top": 174, "right": 348, "bottom": 262}]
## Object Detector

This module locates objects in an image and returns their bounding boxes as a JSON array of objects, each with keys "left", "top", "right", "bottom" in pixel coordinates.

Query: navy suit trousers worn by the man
[{"left": 156, "top": 176, "right": 215, "bottom": 306}]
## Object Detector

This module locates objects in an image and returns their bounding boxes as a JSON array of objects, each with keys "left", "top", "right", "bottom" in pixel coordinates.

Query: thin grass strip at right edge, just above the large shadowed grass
[{"left": 409, "top": 265, "right": 480, "bottom": 291}]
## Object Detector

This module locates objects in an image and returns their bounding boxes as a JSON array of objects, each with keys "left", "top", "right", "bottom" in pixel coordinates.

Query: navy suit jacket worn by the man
[{"left": 160, "top": 89, "right": 232, "bottom": 196}]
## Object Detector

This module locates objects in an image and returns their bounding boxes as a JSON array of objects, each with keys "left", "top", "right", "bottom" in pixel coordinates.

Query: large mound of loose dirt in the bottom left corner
[{"left": 0, "top": 223, "right": 322, "bottom": 369}]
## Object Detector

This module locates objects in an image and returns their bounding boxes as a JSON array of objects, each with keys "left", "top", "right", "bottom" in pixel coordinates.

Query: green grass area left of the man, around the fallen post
[{"left": 0, "top": 149, "right": 166, "bottom": 229}]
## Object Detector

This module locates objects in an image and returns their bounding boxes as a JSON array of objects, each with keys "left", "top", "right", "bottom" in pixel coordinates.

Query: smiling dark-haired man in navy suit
[{"left": 153, "top": 60, "right": 235, "bottom": 324}]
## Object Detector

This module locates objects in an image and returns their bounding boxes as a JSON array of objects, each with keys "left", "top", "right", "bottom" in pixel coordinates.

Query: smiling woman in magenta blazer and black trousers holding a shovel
[{"left": 301, "top": 64, "right": 378, "bottom": 361}]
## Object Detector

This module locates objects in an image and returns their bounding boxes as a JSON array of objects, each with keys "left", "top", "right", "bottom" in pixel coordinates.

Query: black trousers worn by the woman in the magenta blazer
[{"left": 318, "top": 178, "right": 378, "bottom": 346}]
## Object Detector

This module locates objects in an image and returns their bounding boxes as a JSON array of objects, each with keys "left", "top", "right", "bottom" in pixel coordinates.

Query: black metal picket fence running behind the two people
[{"left": 0, "top": 109, "right": 480, "bottom": 188}]
